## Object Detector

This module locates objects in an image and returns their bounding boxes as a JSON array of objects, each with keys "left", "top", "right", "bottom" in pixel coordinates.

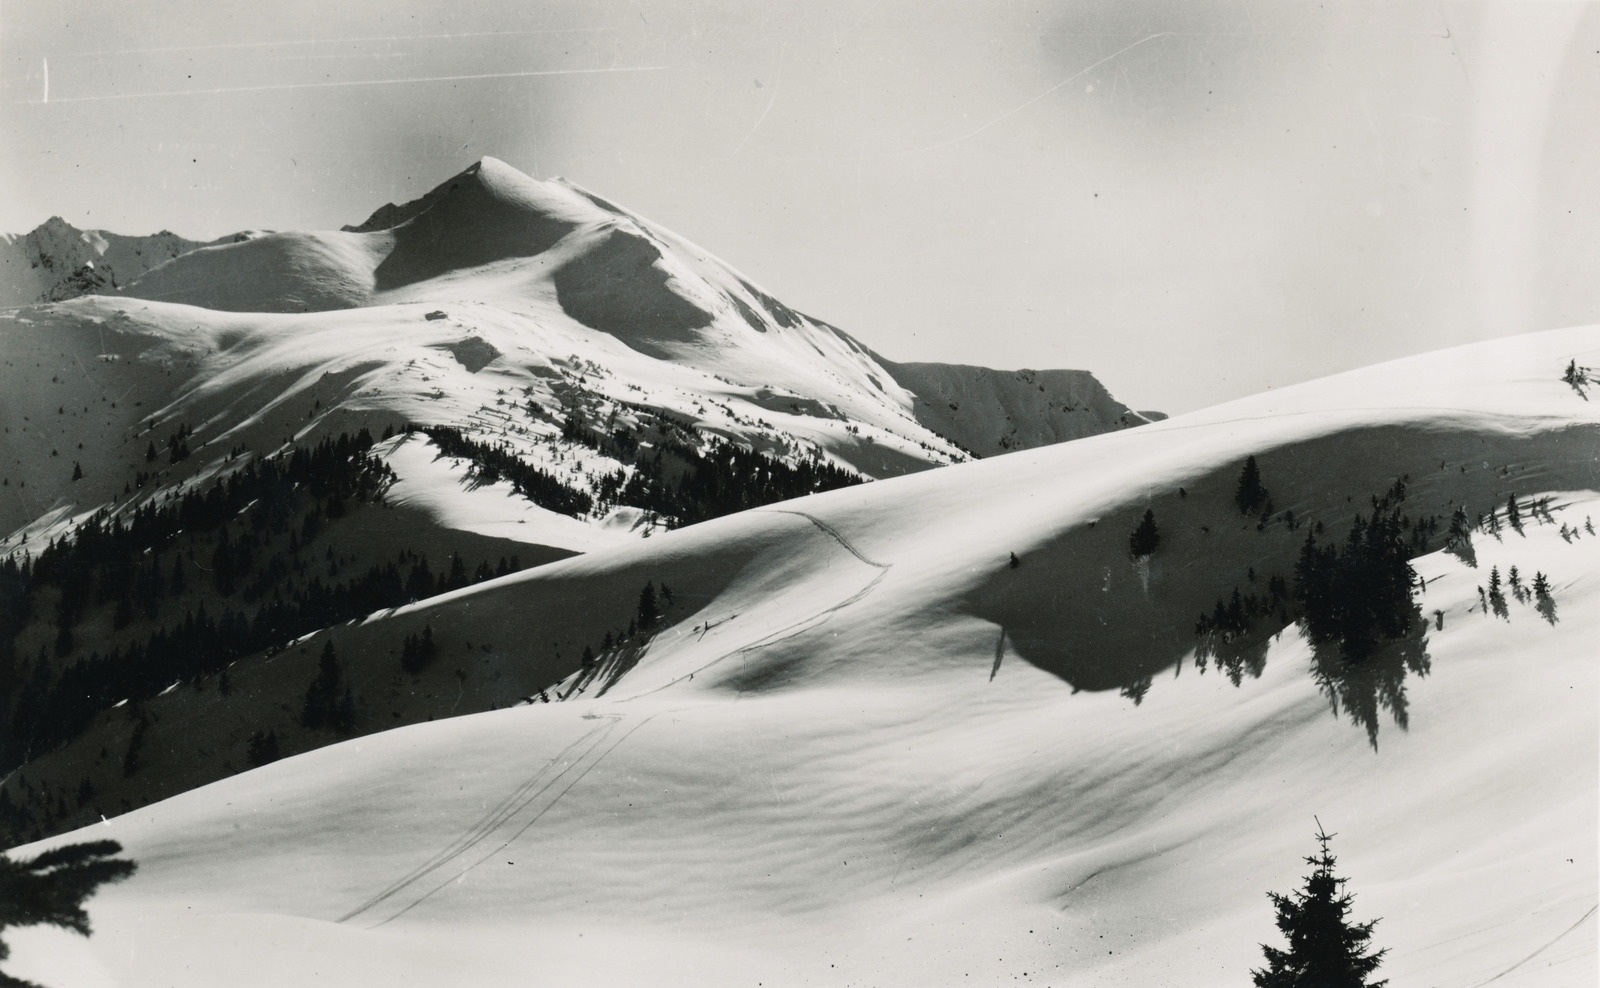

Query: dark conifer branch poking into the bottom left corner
[{"left": 0, "top": 841, "right": 138, "bottom": 988}]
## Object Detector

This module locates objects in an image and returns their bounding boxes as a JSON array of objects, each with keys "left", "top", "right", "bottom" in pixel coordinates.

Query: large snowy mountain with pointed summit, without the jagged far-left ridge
[{"left": 0, "top": 158, "right": 1146, "bottom": 552}]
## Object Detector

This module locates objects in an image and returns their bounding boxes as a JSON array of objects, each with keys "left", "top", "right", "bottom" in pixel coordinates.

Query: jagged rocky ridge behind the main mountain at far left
[{"left": 0, "top": 216, "right": 219, "bottom": 309}]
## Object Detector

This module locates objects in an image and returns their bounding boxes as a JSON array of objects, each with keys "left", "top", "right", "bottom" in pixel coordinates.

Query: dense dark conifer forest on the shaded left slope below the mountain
[{"left": 0, "top": 430, "right": 520, "bottom": 839}]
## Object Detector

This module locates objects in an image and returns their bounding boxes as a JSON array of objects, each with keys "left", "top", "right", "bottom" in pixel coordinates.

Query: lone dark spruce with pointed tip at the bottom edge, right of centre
[{"left": 1250, "top": 822, "right": 1389, "bottom": 988}]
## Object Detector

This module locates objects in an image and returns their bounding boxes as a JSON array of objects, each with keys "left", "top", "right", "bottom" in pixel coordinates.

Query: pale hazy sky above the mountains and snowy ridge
[{"left": 0, "top": 0, "right": 1600, "bottom": 411}]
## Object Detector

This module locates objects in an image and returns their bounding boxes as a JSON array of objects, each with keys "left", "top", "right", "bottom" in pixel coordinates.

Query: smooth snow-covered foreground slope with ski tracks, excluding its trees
[{"left": 11, "top": 328, "right": 1600, "bottom": 988}]
